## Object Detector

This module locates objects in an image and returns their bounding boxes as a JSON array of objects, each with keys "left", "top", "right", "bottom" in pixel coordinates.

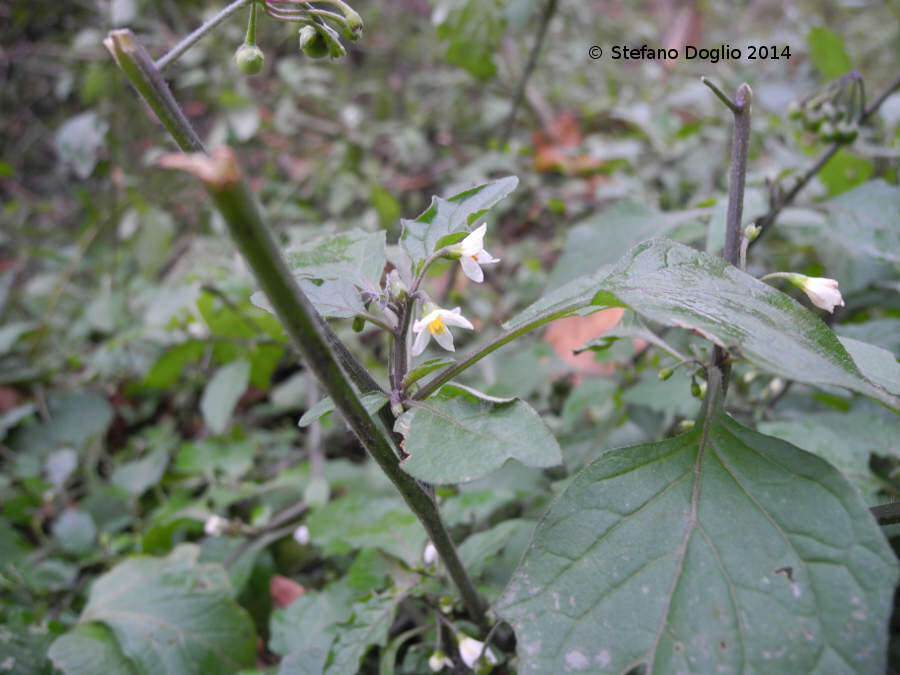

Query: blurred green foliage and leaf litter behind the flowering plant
[{"left": 0, "top": 0, "right": 900, "bottom": 673}]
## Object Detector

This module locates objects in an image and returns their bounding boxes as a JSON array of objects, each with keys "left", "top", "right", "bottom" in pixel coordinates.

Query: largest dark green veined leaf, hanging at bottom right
[{"left": 497, "top": 411, "right": 897, "bottom": 674}]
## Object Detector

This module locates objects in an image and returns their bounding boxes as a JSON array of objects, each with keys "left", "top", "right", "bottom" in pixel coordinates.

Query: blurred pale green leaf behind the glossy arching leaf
[{"left": 547, "top": 201, "right": 710, "bottom": 289}]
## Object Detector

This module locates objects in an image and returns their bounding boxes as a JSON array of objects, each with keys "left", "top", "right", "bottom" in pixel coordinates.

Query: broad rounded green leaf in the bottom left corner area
[{"left": 80, "top": 544, "right": 256, "bottom": 674}]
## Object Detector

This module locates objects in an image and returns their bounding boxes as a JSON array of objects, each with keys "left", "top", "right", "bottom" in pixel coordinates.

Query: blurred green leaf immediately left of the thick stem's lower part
[{"left": 306, "top": 491, "right": 426, "bottom": 565}]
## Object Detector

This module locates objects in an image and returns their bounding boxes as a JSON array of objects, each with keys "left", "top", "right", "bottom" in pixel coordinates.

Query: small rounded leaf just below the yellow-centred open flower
[{"left": 395, "top": 384, "right": 562, "bottom": 484}]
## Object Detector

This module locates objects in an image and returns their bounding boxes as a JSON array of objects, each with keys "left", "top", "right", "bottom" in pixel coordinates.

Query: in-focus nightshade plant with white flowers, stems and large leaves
[{"left": 38, "top": 0, "right": 900, "bottom": 674}]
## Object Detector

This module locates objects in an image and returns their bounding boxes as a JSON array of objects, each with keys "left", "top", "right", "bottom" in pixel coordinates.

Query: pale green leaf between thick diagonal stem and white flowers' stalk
[{"left": 285, "top": 230, "right": 386, "bottom": 292}]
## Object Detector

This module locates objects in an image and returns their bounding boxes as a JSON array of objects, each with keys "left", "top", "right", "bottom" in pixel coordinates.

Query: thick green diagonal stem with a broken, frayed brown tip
[{"left": 105, "top": 31, "right": 488, "bottom": 630}]
